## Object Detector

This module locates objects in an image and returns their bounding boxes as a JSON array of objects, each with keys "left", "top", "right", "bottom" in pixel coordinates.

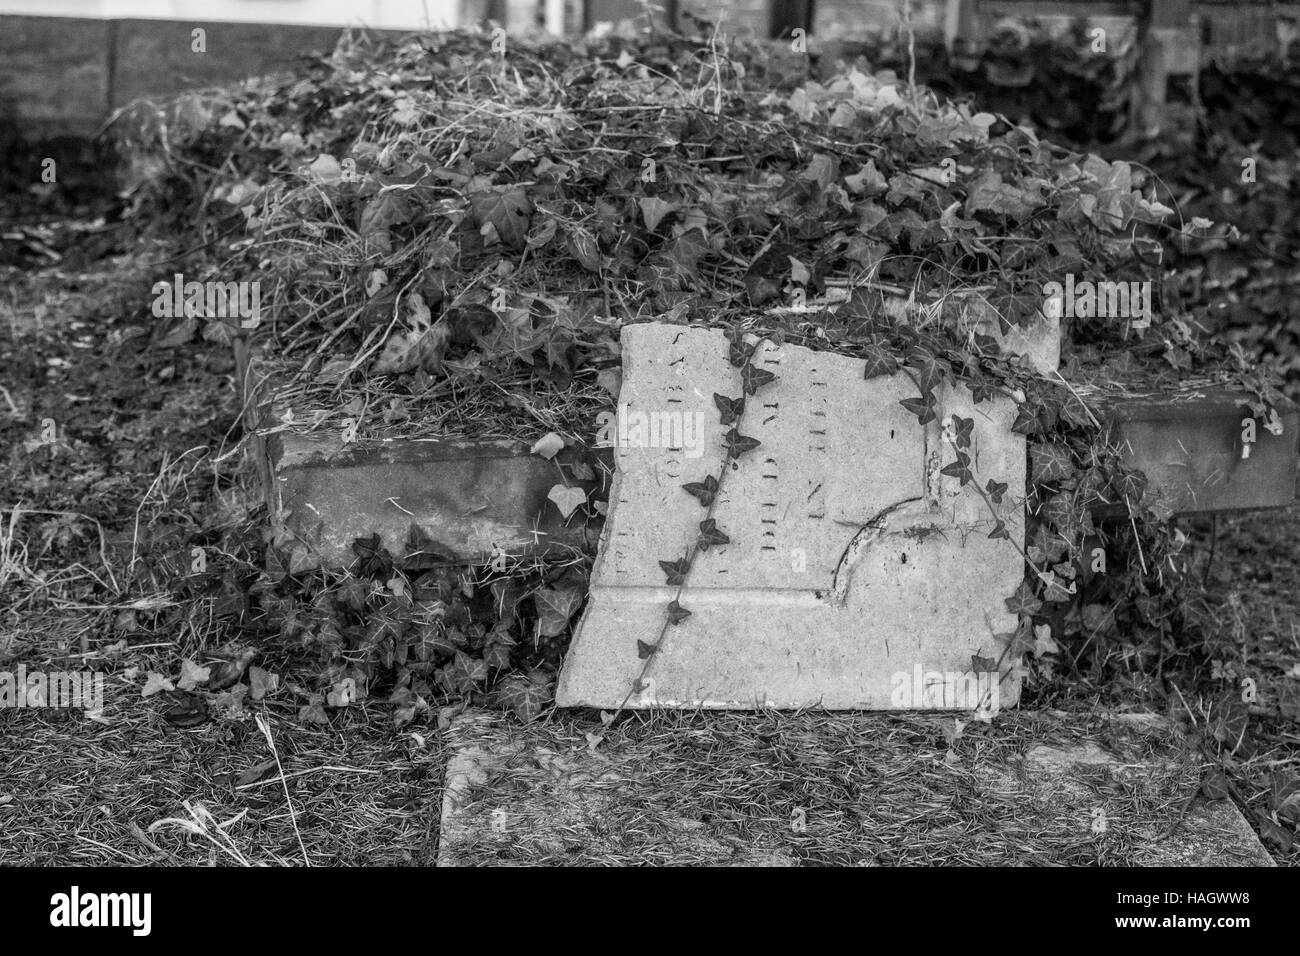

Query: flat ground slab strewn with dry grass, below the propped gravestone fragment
[{"left": 438, "top": 711, "right": 1274, "bottom": 866}]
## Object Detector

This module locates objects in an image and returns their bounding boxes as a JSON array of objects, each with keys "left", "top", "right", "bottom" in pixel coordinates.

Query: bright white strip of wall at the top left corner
[{"left": 0, "top": 0, "right": 462, "bottom": 30}]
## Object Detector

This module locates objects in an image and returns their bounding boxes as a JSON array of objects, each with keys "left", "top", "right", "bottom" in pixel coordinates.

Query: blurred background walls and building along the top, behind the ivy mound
[{"left": 0, "top": 0, "right": 1296, "bottom": 139}]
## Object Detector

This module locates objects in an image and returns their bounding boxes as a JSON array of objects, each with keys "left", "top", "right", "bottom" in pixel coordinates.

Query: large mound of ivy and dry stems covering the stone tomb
[{"left": 111, "top": 26, "right": 1279, "bottom": 717}]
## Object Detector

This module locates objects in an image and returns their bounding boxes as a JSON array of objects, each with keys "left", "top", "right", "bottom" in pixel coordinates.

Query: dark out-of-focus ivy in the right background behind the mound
[{"left": 873, "top": 21, "right": 1300, "bottom": 399}]
